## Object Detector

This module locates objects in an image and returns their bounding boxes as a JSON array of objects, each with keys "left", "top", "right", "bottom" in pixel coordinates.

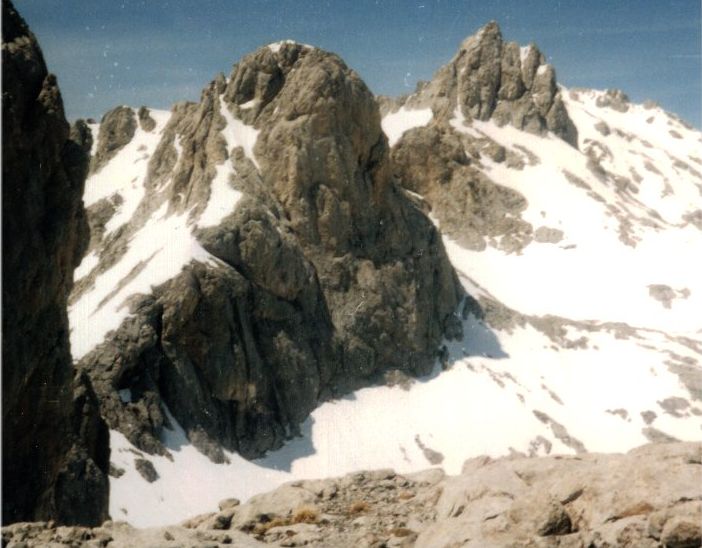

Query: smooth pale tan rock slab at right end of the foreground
[{"left": 416, "top": 443, "right": 702, "bottom": 547}]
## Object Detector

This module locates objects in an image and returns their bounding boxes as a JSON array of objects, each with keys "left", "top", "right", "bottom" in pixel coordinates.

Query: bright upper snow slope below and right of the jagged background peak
[{"left": 448, "top": 112, "right": 702, "bottom": 333}]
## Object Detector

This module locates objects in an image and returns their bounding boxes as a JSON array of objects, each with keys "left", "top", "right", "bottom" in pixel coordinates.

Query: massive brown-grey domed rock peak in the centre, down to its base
[{"left": 72, "top": 43, "right": 461, "bottom": 460}]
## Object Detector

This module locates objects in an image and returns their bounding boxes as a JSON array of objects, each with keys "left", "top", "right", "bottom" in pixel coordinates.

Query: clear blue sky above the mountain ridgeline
[{"left": 15, "top": 0, "right": 702, "bottom": 127}]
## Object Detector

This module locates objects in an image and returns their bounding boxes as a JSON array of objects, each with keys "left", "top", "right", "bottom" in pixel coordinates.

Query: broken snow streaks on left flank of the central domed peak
[{"left": 68, "top": 98, "right": 258, "bottom": 360}]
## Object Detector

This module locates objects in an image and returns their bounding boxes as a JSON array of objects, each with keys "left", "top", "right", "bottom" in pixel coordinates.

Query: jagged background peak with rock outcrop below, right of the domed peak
[{"left": 388, "top": 22, "right": 578, "bottom": 253}]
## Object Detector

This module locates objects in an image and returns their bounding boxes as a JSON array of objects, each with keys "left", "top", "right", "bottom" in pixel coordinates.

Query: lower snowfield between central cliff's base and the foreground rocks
[{"left": 110, "top": 292, "right": 702, "bottom": 527}]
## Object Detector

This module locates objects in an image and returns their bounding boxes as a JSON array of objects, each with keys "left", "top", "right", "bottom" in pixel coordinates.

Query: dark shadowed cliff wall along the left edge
[{"left": 2, "top": 1, "right": 109, "bottom": 524}]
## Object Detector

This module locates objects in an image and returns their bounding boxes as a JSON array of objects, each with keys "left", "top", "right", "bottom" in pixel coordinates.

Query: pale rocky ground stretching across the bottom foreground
[{"left": 2, "top": 443, "right": 702, "bottom": 548}]
